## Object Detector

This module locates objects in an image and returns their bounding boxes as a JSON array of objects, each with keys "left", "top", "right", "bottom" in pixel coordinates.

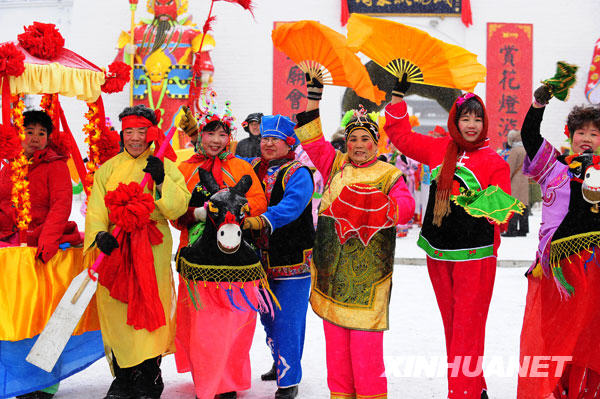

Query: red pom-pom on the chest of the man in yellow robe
[{"left": 104, "top": 182, "right": 154, "bottom": 233}]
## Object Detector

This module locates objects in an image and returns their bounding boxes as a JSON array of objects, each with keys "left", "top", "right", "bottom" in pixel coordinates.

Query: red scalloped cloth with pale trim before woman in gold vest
[{"left": 322, "top": 183, "right": 397, "bottom": 246}]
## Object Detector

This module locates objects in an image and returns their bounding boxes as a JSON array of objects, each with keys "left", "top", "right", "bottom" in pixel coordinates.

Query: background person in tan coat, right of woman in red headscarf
[{"left": 502, "top": 130, "right": 529, "bottom": 237}]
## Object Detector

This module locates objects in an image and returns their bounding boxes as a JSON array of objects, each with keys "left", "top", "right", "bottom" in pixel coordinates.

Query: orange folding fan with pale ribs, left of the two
[{"left": 271, "top": 21, "right": 385, "bottom": 104}]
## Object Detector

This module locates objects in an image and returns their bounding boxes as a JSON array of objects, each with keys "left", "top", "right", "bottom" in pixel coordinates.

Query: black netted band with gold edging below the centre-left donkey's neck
[{"left": 177, "top": 257, "right": 266, "bottom": 283}]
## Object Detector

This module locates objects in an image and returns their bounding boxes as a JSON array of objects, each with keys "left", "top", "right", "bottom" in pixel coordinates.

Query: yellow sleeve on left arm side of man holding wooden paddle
[{"left": 83, "top": 164, "right": 111, "bottom": 252}]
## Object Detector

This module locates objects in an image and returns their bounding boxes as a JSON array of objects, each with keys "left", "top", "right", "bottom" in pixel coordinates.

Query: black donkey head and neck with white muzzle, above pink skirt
[{"left": 179, "top": 169, "right": 258, "bottom": 272}]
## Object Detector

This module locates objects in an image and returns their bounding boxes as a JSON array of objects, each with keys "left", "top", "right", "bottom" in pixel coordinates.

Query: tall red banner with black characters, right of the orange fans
[{"left": 485, "top": 22, "right": 533, "bottom": 149}]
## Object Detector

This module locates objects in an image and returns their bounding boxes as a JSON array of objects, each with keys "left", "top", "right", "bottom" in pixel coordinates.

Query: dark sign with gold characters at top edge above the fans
[{"left": 342, "top": 0, "right": 461, "bottom": 16}]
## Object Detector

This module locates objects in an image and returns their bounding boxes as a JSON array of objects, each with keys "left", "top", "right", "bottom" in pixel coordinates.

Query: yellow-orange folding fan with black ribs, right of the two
[{"left": 347, "top": 14, "right": 486, "bottom": 91}]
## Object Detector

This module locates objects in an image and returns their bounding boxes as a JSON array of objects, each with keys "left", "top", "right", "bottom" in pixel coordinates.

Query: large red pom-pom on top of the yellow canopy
[{"left": 17, "top": 22, "right": 65, "bottom": 60}]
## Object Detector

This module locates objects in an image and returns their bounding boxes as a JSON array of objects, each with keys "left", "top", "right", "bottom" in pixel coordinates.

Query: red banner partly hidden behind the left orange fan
[{"left": 273, "top": 22, "right": 306, "bottom": 122}]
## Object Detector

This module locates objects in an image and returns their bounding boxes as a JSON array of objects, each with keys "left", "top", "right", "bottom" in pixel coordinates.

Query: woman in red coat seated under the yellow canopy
[{"left": 0, "top": 111, "right": 83, "bottom": 263}]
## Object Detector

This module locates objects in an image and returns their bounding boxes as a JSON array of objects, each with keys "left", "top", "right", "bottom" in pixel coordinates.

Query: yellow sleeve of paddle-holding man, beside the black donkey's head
[{"left": 154, "top": 159, "right": 192, "bottom": 220}]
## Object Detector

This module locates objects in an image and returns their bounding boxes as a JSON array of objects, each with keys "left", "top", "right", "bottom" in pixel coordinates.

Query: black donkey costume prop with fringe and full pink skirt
[{"left": 176, "top": 170, "right": 274, "bottom": 399}]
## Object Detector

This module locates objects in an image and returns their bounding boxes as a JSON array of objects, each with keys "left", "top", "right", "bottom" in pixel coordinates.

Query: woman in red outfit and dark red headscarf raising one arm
[{"left": 385, "top": 75, "right": 510, "bottom": 399}]
